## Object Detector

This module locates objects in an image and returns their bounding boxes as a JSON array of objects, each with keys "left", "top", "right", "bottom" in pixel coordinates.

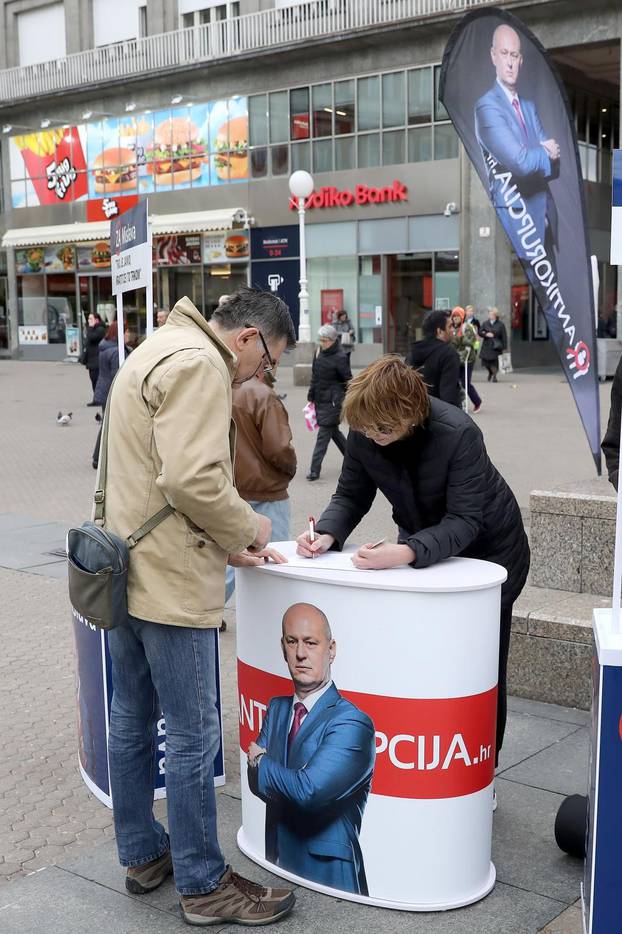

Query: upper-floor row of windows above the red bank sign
[{"left": 248, "top": 65, "right": 458, "bottom": 178}]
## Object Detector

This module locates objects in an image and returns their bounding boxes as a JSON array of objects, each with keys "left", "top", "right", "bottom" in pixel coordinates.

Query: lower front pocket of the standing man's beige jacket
[{"left": 181, "top": 528, "right": 227, "bottom": 613}]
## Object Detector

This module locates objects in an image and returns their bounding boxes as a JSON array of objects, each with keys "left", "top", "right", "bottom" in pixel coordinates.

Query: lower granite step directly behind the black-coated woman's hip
[{"left": 508, "top": 587, "right": 611, "bottom": 710}]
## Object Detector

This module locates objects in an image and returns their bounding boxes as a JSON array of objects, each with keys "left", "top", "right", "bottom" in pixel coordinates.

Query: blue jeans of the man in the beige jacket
[{"left": 108, "top": 617, "right": 226, "bottom": 895}]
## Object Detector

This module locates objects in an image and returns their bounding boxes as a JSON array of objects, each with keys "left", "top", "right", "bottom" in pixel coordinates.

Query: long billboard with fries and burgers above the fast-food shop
[{"left": 9, "top": 97, "right": 248, "bottom": 209}]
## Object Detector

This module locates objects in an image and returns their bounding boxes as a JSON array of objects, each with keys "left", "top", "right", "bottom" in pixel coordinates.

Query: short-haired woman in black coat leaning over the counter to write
[{"left": 298, "top": 355, "right": 529, "bottom": 772}]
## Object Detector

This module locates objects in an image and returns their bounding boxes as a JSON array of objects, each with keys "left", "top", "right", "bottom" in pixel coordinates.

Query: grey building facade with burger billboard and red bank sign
[{"left": 0, "top": 0, "right": 622, "bottom": 366}]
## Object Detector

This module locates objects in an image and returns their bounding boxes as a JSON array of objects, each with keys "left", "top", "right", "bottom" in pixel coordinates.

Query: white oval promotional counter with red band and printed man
[{"left": 236, "top": 542, "right": 506, "bottom": 911}]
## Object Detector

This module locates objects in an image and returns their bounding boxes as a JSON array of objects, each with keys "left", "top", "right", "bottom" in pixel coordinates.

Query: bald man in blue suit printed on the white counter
[{"left": 248, "top": 603, "right": 376, "bottom": 895}]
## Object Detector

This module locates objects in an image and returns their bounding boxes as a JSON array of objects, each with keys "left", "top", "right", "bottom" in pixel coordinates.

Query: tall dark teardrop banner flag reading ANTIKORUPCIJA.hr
[{"left": 439, "top": 7, "right": 601, "bottom": 474}]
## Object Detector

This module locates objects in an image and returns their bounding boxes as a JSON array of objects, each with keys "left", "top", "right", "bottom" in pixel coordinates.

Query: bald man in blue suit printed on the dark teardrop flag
[{"left": 475, "top": 23, "right": 561, "bottom": 259}]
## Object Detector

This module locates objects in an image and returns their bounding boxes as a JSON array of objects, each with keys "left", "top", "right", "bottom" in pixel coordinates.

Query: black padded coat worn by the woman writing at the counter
[{"left": 317, "top": 399, "right": 529, "bottom": 595}]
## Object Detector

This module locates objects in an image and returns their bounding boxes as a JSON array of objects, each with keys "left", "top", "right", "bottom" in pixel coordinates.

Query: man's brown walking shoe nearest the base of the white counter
[{"left": 179, "top": 868, "right": 296, "bottom": 925}]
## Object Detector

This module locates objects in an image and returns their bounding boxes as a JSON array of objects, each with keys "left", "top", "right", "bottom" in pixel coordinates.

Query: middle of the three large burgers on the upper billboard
[{"left": 147, "top": 117, "right": 207, "bottom": 187}]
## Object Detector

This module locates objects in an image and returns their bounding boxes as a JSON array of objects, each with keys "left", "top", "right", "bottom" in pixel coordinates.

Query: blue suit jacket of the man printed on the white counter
[{"left": 248, "top": 685, "right": 376, "bottom": 895}]
